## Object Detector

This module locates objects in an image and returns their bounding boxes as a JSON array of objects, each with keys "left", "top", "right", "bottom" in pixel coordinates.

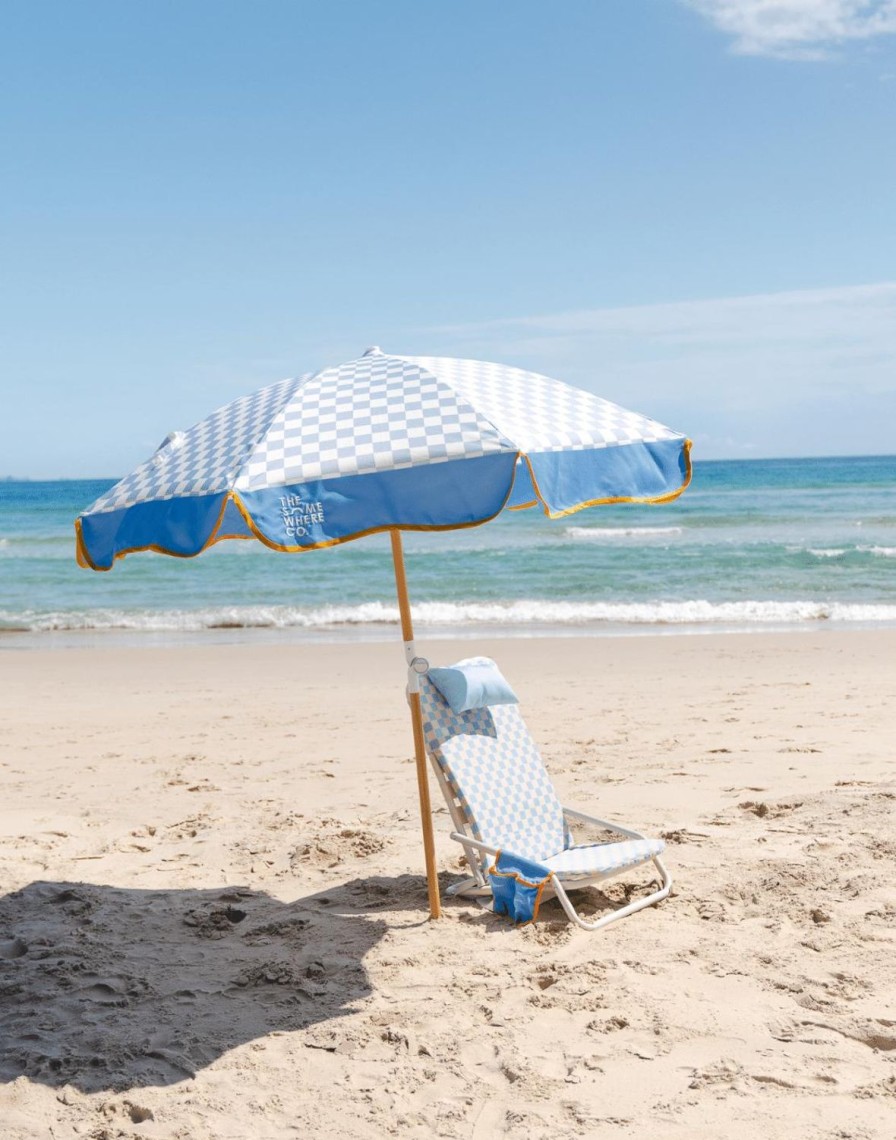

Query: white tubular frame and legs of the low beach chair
[{"left": 427, "top": 670, "right": 673, "bottom": 930}]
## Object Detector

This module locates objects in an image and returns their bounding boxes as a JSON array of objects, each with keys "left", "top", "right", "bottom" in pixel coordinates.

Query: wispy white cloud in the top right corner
[{"left": 684, "top": 0, "right": 896, "bottom": 59}]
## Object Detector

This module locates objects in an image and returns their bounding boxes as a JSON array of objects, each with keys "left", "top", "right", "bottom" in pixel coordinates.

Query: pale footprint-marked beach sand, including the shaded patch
[{"left": 0, "top": 629, "right": 896, "bottom": 1140}]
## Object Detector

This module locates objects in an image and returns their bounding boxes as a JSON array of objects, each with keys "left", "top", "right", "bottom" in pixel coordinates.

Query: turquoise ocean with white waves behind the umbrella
[{"left": 0, "top": 456, "right": 896, "bottom": 645}]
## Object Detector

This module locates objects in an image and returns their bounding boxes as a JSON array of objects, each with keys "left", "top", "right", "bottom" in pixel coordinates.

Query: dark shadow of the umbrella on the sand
[{"left": 0, "top": 876, "right": 422, "bottom": 1092}]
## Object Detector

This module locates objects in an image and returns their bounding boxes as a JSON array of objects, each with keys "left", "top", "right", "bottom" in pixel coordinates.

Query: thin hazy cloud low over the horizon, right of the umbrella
[{"left": 417, "top": 282, "right": 896, "bottom": 455}]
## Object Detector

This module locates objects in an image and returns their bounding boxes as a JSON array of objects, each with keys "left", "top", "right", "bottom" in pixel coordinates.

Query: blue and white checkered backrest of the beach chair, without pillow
[{"left": 421, "top": 658, "right": 568, "bottom": 860}]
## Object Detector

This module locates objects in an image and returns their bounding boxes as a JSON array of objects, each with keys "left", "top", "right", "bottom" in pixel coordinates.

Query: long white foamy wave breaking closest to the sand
[{"left": 0, "top": 599, "right": 896, "bottom": 633}]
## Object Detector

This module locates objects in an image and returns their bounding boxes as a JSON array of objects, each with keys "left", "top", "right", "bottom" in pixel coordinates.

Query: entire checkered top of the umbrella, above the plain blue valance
[{"left": 85, "top": 349, "right": 681, "bottom": 514}]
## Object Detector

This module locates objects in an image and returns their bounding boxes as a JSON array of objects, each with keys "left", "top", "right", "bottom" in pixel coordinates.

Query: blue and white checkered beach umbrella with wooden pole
[{"left": 75, "top": 348, "right": 691, "bottom": 918}]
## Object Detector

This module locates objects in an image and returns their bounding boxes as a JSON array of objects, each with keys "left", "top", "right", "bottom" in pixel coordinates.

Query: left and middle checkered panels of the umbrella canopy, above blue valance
[{"left": 88, "top": 352, "right": 519, "bottom": 514}]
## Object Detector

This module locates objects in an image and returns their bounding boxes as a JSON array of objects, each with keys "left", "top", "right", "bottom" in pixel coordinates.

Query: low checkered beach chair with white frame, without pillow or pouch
[{"left": 420, "top": 658, "right": 671, "bottom": 930}]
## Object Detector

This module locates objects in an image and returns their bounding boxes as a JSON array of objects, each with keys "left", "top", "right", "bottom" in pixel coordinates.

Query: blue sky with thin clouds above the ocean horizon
[{"left": 0, "top": 0, "right": 896, "bottom": 478}]
